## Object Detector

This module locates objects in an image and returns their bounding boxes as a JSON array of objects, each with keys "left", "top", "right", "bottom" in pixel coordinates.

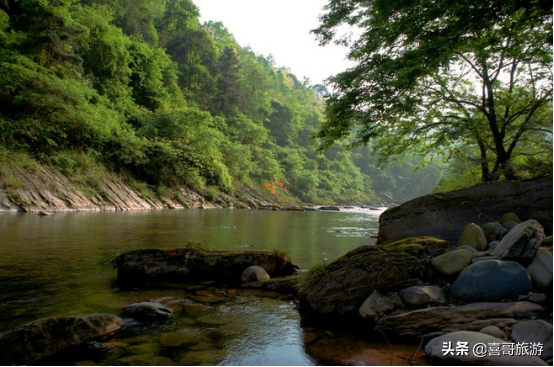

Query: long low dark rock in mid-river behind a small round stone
[{"left": 116, "top": 246, "right": 298, "bottom": 285}]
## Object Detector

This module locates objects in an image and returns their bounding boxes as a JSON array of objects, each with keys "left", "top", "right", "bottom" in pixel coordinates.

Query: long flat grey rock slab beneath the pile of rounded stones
[{"left": 375, "top": 302, "right": 544, "bottom": 339}]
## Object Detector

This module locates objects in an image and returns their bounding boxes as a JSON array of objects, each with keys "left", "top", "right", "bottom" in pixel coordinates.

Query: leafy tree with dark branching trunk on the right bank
[{"left": 314, "top": 0, "right": 552, "bottom": 181}]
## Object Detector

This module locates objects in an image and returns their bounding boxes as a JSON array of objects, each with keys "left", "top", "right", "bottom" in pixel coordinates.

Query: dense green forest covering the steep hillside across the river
[{"left": 0, "top": 0, "right": 552, "bottom": 207}]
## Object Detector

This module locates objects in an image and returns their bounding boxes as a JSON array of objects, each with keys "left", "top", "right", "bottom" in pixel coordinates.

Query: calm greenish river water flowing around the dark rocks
[{"left": 0, "top": 209, "right": 388, "bottom": 365}]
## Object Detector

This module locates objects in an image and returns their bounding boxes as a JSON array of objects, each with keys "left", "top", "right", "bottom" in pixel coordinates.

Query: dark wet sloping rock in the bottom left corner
[{"left": 0, "top": 314, "right": 125, "bottom": 365}]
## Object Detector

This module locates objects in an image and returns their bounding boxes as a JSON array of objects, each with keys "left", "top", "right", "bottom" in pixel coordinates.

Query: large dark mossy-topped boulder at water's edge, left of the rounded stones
[{"left": 299, "top": 246, "right": 424, "bottom": 314}]
